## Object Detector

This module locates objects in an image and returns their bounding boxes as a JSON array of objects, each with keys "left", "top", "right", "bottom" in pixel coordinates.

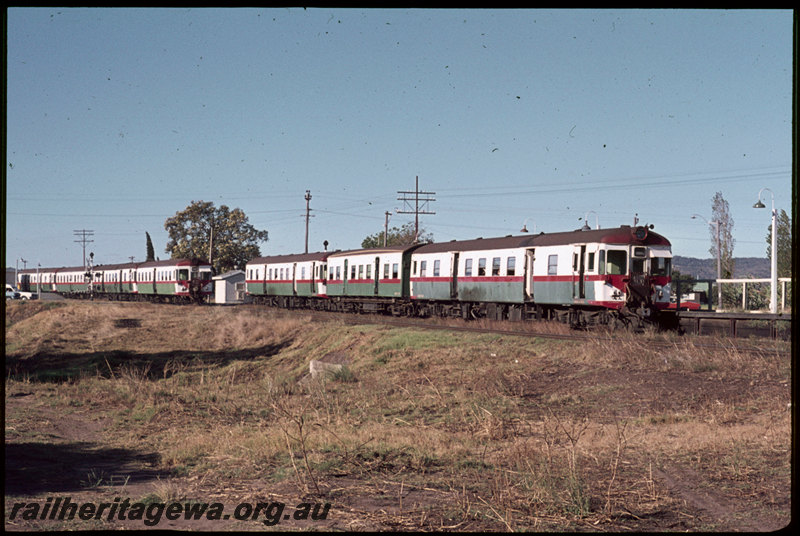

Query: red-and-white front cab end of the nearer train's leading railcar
[{"left": 597, "top": 227, "right": 672, "bottom": 319}]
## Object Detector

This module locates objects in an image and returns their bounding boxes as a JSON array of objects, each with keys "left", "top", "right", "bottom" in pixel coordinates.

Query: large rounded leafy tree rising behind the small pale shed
[{"left": 164, "top": 201, "right": 269, "bottom": 273}]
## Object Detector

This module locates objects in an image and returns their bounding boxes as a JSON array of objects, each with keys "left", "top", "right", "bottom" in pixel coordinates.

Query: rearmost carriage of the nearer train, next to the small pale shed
[{"left": 245, "top": 252, "right": 328, "bottom": 308}]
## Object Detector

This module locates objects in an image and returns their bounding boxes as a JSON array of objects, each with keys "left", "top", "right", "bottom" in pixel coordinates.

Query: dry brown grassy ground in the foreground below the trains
[{"left": 6, "top": 303, "right": 791, "bottom": 531}]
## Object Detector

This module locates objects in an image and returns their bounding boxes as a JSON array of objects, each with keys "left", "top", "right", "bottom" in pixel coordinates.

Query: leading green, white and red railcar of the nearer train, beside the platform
[{"left": 411, "top": 226, "right": 674, "bottom": 326}]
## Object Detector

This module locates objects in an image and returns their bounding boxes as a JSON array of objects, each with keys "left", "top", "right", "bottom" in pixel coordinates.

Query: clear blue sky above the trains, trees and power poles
[{"left": 5, "top": 8, "right": 793, "bottom": 268}]
